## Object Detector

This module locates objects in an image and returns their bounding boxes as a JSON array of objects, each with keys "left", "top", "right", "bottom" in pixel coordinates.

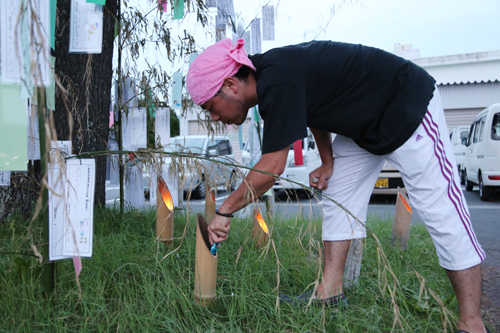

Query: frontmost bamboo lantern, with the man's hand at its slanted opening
[{"left": 193, "top": 214, "right": 217, "bottom": 306}]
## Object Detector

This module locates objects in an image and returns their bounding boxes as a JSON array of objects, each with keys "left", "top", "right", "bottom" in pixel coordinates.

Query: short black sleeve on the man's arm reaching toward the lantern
[{"left": 259, "top": 85, "right": 307, "bottom": 154}]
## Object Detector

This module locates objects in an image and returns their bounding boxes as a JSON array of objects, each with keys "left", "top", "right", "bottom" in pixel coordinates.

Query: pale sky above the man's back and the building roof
[{"left": 204, "top": 0, "right": 500, "bottom": 57}]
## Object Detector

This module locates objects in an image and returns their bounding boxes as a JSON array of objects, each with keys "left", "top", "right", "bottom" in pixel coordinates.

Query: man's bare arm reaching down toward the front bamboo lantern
[{"left": 208, "top": 146, "right": 290, "bottom": 243}]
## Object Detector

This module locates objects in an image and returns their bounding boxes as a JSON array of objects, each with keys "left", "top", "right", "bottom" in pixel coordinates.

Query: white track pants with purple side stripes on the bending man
[{"left": 323, "top": 88, "right": 486, "bottom": 270}]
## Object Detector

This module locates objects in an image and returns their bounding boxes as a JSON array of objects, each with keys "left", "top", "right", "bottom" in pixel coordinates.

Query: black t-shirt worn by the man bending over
[{"left": 250, "top": 41, "right": 435, "bottom": 155}]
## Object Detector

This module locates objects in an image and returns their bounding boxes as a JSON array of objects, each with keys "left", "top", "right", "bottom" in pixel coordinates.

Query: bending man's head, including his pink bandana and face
[{"left": 186, "top": 39, "right": 257, "bottom": 125}]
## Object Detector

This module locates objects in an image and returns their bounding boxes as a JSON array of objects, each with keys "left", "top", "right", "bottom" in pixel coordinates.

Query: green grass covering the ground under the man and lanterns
[{"left": 0, "top": 206, "right": 457, "bottom": 332}]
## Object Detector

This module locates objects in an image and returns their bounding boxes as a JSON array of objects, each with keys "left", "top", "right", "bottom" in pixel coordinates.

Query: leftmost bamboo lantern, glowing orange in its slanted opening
[{"left": 156, "top": 176, "right": 174, "bottom": 245}]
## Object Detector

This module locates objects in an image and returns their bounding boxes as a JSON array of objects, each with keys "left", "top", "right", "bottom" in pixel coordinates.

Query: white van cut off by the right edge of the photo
[{"left": 465, "top": 103, "right": 500, "bottom": 201}]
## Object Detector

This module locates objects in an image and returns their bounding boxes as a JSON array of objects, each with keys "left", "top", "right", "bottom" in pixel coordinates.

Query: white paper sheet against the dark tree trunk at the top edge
[{"left": 69, "top": 0, "right": 103, "bottom": 53}]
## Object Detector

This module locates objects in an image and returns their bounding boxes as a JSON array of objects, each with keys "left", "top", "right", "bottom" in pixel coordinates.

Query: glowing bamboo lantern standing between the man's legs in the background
[{"left": 391, "top": 191, "right": 412, "bottom": 251}]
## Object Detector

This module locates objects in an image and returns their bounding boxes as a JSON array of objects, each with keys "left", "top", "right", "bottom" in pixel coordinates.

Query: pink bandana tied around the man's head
[{"left": 186, "top": 38, "right": 255, "bottom": 105}]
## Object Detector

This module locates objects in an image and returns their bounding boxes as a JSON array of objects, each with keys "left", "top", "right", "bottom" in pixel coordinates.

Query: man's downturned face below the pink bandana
[{"left": 201, "top": 93, "right": 248, "bottom": 125}]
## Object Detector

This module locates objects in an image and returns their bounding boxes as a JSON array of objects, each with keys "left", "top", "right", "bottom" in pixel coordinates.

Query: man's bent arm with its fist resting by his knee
[{"left": 309, "top": 128, "right": 333, "bottom": 190}]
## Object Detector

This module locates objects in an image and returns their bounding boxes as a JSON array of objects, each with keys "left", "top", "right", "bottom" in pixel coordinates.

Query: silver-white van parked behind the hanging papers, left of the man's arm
[{"left": 143, "top": 135, "right": 237, "bottom": 199}]
